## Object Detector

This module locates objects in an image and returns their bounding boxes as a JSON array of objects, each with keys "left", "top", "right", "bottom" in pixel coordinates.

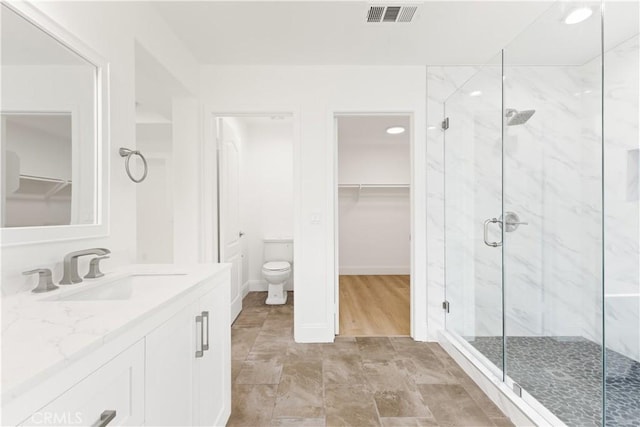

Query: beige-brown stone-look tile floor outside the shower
[{"left": 227, "top": 292, "right": 513, "bottom": 427}]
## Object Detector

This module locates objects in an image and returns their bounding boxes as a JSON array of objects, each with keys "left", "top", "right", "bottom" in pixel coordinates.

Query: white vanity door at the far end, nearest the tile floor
[{"left": 195, "top": 283, "right": 231, "bottom": 426}]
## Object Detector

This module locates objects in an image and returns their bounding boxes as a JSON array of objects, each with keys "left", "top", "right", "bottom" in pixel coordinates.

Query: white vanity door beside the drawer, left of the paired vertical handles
[{"left": 145, "top": 304, "right": 199, "bottom": 426}]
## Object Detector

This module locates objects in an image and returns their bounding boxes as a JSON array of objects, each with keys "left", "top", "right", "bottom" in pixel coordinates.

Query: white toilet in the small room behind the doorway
[{"left": 262, "top": 238, "right": 293, "bottom": 305}]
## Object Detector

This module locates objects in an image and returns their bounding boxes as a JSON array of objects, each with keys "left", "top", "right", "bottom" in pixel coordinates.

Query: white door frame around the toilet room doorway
[{"left": 199, "top": 106, "right": 301, "bottom": 300}]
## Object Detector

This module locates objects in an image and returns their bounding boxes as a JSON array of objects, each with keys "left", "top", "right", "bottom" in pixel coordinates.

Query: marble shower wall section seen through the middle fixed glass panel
[{"left": 503, "top": 63, "right": 602, "bottom": 342}]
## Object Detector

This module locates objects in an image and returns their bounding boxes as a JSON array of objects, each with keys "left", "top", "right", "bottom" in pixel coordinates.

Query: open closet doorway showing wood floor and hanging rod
[{"left": 336, "top": 114, "right": 411, "bottom": 336}]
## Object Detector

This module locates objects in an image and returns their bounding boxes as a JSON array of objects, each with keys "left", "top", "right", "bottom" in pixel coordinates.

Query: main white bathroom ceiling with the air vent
[{"left": 155, "top": 0, "right": 552, "bottom": 65}]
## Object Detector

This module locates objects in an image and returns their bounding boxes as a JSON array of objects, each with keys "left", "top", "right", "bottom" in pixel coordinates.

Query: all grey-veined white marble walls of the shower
[{"left": 427, "top": 37, "right": 640, "bottom": 360}]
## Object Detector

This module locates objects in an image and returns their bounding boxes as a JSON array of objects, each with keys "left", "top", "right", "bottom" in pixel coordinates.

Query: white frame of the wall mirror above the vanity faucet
[{"left": 0, "top": 0, "right": 110, "bottom": 247}]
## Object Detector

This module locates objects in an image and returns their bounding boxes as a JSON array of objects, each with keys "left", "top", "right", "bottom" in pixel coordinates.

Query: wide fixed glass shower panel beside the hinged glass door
[{"left": 503, "top": 2, "right": 603, "bottom": 426}]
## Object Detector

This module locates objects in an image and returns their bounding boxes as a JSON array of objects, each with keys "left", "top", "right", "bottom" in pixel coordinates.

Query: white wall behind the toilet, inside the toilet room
[{"left": 237, "top": 118, "right": 293, "bottom": 291}]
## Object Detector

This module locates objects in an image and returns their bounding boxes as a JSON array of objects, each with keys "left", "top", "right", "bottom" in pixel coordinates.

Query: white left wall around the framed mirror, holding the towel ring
[{"left": 2, "top": 1, "right": 199, "bottom": 295}]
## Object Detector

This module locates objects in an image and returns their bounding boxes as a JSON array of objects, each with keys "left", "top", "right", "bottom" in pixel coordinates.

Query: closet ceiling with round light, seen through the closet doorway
[{"left": 338, "top": 115, "right": 411, "bottom": 147}]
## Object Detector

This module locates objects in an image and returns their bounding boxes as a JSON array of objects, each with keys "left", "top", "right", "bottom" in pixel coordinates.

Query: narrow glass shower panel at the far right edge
[{"left": 603, "top": 1, "right": 640, "bottom": 426}]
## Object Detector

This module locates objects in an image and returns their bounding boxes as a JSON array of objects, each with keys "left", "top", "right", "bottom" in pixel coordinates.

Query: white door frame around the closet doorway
[{"left": 329, "top": 109, "right": 426, "bottom": 340}]
